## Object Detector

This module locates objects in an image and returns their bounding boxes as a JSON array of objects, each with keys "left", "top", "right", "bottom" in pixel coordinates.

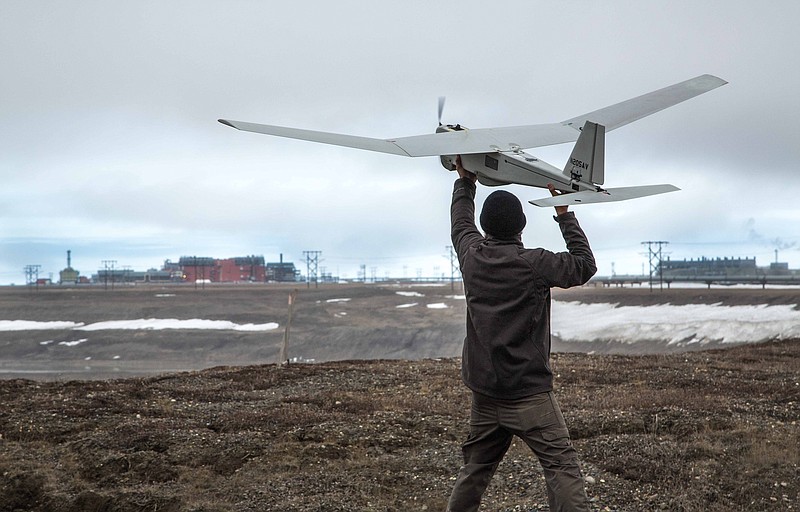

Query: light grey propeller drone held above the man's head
[{"left": 219, "top": 75, "right": 728, "bottom": 206}]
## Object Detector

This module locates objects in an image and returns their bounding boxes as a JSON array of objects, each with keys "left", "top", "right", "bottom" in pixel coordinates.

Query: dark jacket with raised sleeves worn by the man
[{"left": 450, "top": 179, "right": 597, "bottom": 399}]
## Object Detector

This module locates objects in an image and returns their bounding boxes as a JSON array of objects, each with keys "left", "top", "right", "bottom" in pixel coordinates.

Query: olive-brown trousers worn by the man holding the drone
[{"left": 447, "top": 392, "right": 589, "bottom": 512}]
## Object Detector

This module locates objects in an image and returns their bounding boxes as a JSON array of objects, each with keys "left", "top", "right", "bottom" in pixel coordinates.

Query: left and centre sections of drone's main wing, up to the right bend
[{"left": 219, "top": 119, "right": 578, "bottom": 156}]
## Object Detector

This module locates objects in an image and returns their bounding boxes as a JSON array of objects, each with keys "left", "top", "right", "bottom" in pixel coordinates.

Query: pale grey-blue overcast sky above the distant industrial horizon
[{"left": 0, "top": 0, "right": 800, "bottom": 284}]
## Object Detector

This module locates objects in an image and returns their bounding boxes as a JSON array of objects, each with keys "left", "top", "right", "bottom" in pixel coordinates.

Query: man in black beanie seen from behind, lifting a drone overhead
[{"left": 448, "top": 157, "right": 597, "bottom": 512}]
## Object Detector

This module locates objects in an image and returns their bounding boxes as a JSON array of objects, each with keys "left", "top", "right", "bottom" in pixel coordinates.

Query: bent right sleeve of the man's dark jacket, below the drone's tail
[{"left": 542, "top": 212, "right": 597, "bottom": 288}]
